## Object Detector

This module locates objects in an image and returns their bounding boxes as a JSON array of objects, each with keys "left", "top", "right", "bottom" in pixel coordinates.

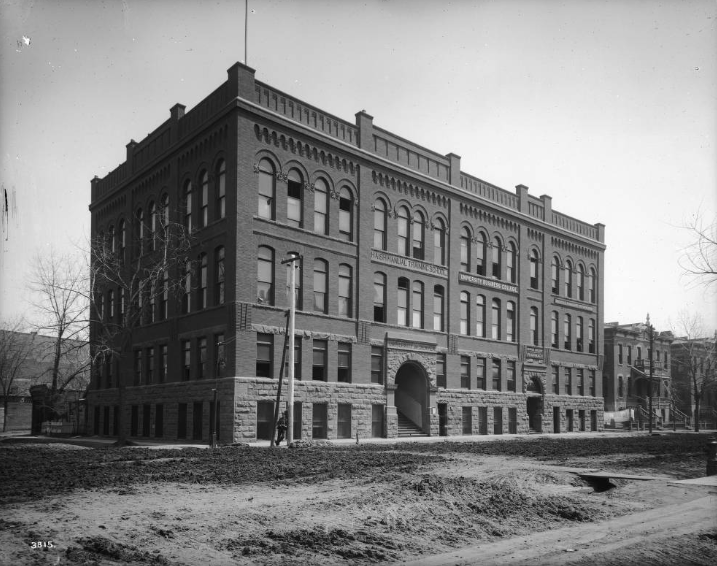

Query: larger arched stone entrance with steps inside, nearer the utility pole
[{"left": 394, "top": 362, "right": 431, "bottom": 434}]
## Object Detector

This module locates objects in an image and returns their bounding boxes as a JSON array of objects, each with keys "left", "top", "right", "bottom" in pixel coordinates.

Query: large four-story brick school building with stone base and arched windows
[{"left": 88, "top": 63, "right": 605, "bottom": 442}]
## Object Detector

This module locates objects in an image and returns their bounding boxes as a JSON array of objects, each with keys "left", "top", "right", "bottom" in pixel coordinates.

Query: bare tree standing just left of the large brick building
[{"left": 30, "top": 250, "right": 90, "bottom": 418}]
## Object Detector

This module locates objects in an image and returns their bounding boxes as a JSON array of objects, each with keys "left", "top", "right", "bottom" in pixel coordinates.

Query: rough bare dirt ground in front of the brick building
[{"left": 0, "top": 435, "right": 717, "bottom": 566}]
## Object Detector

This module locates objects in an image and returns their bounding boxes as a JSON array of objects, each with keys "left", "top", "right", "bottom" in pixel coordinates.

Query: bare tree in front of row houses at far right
[{"left": 672, "top": 313, "right": 717, "bottom": 432}]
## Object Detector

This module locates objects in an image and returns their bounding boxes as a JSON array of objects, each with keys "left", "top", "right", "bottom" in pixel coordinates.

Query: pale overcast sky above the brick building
[{"left": 0, "top": 0, "right": 717, "bottom": 333}]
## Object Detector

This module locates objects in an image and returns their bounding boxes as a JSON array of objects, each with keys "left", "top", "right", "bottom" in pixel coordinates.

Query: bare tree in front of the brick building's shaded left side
[{"left": 89, "top": 208, "right": 194, "bottom": 445}]
